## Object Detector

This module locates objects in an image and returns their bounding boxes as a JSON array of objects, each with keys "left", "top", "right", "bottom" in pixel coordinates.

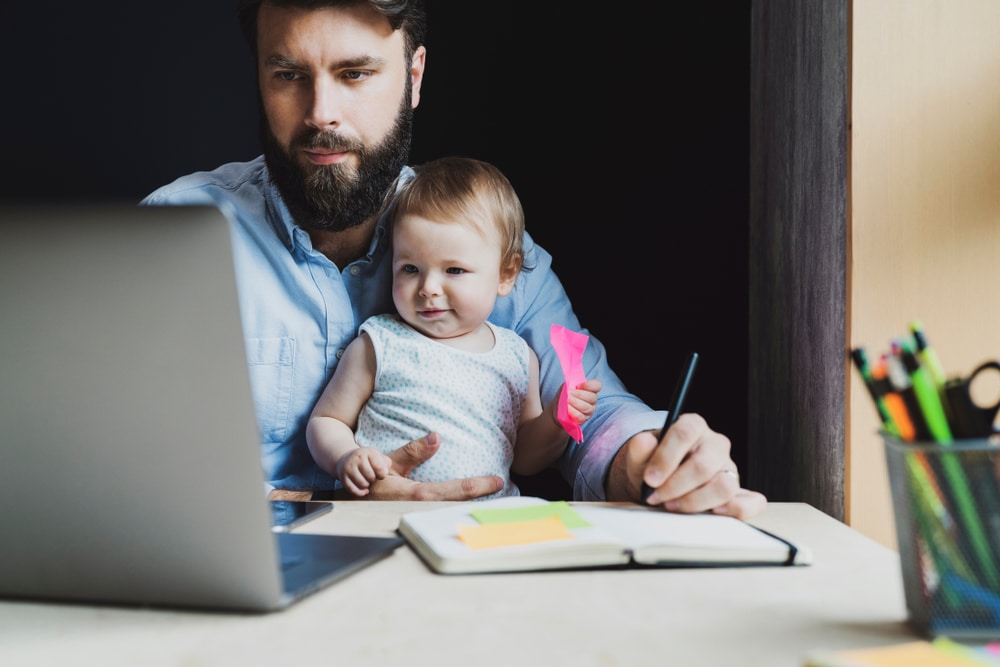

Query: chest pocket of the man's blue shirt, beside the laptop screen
[{"left": 247, "top": 337, "right": 295, "bottom": 443}]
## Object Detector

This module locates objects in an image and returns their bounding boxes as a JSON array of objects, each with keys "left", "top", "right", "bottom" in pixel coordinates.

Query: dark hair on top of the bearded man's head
[{"left": 236, "top": 0, "right": 427, "bottom": 59}]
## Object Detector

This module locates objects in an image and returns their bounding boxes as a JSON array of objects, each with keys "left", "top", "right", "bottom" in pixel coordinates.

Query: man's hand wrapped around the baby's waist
[{"left": 366, "top": 433, "right": 503, "bottom": 500}]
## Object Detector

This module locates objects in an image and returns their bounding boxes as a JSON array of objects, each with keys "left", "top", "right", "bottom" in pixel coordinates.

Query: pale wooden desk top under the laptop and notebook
[{"left": 0, "top": 501, "right": 915, "bottom": 667}]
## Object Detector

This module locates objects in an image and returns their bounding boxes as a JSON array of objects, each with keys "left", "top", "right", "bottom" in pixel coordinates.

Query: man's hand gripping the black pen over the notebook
[{"left": 606, "top": 414, "right": 767, "bottom": 519}]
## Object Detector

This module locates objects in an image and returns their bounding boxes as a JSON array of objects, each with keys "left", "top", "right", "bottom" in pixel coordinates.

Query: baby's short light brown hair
[{"left": 392, "top": 157, "right": 531, "bottom": 270}]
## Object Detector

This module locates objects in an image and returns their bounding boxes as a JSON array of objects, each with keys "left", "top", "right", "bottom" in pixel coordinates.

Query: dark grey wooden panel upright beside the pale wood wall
[{"left": 747, "top": 0, "right": 848, "bottom": 519}]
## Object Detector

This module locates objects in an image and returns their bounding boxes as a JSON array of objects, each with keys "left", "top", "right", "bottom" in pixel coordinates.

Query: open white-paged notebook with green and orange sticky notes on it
[{"left": 399, "top": 496, "right": 812, "bottom": 574}]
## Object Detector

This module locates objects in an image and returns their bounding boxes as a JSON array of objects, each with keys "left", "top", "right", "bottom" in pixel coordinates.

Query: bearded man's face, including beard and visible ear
[{"left": 258, "top": 4, "right": 424, "bottom": 231}]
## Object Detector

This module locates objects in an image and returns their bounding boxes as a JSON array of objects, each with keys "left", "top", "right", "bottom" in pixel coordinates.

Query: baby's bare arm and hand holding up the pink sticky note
[{"left": 511, "top": 350, "right": 601, "bottom": 475}]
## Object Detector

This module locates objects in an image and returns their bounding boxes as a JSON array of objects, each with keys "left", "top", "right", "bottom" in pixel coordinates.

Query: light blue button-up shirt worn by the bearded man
[{"left": 141, "top": 157, "right": 664, "bottom": 500}]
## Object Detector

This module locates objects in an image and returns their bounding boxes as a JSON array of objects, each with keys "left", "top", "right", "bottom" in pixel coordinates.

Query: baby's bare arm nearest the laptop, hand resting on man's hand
[{"left": 306, "top": 333, "right": 391, "bottom": 496}]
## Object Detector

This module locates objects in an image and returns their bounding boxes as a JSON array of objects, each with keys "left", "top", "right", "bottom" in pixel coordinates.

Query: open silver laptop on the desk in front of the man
[{"left": 0, "top": 203, "right": 402, "bottom": 611}]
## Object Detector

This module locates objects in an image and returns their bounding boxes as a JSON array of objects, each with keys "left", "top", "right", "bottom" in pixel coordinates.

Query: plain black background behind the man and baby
[{"left": 0, "top": 5, "right": 750, "bottom": 467}]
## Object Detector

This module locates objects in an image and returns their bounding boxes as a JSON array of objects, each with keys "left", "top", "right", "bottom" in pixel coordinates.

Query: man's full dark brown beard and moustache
[{"left": 261, "top": 90, "right": 413, "bottom": 232}]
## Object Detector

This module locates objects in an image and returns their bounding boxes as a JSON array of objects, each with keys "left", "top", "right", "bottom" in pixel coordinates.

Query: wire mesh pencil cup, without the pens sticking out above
[{"left": 883, "top": 435, "right": 1000, "bottom": 639}]
